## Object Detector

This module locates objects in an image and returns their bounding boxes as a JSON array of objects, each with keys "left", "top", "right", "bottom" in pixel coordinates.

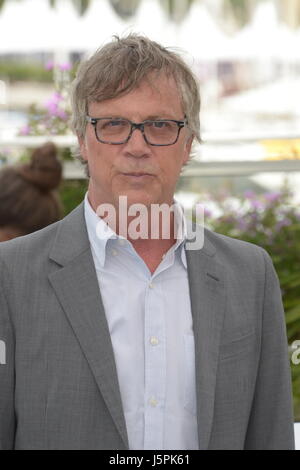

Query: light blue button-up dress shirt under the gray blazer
[{"left": 85, "top": 194, "right": 198, "bottom": 450}]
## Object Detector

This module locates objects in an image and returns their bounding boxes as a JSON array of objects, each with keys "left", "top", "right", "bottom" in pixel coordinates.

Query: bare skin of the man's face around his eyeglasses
[{"left": 79, "top": 76, "right": 192, "bottom": 209}]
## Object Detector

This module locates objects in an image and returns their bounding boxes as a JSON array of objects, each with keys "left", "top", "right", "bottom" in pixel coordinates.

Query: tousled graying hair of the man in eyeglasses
[{"left": 71, "top": 34, "right": 201, "bottom": 174}]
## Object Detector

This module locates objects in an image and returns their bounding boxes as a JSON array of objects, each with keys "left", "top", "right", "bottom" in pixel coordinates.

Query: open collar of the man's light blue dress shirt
[{"left": 84, "top": 192, "right": 187, "bottom": 268}]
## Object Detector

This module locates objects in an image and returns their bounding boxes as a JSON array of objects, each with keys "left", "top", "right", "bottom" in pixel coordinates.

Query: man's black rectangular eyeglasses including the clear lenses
[{"left": 86, "top": 116, "right": 187, "bottom": 147}]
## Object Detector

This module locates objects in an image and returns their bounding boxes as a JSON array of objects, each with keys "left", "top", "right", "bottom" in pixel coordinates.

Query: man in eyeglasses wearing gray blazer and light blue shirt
[{"left": 0, "top": 35, "right": 294, "bottom": 450}]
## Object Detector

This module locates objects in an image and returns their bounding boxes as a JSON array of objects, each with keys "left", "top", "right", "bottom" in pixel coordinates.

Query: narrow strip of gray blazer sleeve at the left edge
[{"left": 0, "top": 255, "right": 15, "bottom": 450}]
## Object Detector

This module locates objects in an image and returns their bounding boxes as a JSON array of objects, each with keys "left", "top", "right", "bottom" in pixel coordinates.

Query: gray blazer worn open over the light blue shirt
[{"left": 0, "top": 204, "right": 294, "bottom": 450}]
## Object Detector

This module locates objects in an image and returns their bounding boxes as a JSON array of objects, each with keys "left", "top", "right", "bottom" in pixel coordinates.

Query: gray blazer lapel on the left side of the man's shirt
[{"left": 49, "top": 204, "right": 129, "bottom": 448}]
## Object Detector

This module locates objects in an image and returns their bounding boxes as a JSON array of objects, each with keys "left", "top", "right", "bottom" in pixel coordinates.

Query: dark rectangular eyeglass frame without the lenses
[{"left": 86, "top": 114, "right": 188, "bottom": 147}]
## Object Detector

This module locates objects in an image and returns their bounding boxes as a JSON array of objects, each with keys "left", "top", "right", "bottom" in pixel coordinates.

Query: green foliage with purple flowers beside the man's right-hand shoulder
[{"left": 205, "top": 188, "right": 300, "bottom": 421}]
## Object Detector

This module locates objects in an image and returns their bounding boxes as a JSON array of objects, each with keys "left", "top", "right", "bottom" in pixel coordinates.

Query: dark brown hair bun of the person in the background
[{"left": 19, "top": 142, "right": 62, "bottom": 191}]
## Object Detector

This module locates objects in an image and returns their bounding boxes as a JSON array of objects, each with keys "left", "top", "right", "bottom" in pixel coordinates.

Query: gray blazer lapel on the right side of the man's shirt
[{"left": 186, "top": 225, "right": 225, "bottom": 450}]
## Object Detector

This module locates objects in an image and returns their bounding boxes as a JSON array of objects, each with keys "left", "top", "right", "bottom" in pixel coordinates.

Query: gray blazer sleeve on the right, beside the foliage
[{"left": 245, "top": 250, "right": 295, "bottom": 450}]
